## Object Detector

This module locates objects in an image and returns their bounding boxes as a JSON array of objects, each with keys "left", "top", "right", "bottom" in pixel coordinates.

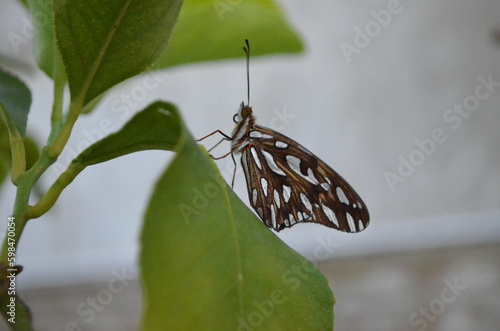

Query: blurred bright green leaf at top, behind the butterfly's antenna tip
[{"left": 158, "top": 0, "right": 302, "bottom": 68}]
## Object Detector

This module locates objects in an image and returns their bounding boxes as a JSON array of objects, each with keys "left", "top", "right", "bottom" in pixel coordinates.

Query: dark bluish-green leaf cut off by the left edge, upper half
[{"left": 0, "top": 68, "right": 31, "bottom": 137}]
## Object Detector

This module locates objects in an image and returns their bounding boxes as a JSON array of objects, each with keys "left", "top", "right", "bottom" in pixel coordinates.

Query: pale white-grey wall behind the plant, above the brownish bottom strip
[{"left": 0, "top": 0, "right": 500, "bottom": 286}]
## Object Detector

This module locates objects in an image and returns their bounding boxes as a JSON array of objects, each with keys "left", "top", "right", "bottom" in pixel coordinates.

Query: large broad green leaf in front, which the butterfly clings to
[{"left": 140, "top": 111, "right": 334, "bottom": 331}]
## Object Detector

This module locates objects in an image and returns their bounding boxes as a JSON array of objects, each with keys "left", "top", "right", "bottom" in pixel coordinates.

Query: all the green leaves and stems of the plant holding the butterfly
[{"left": 0, "top": 0, "right": 334, "bottom": 330}]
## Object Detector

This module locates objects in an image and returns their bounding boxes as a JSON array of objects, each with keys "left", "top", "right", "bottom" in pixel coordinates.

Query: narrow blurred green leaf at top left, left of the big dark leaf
[{"left": 27, "top": 0, "right": 55, "bottom": 78}]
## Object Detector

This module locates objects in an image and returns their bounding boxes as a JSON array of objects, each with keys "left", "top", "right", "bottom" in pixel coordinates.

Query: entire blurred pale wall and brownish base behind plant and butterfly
[{"left": 0, "top": 0, "right": 500, "bottom": 331}]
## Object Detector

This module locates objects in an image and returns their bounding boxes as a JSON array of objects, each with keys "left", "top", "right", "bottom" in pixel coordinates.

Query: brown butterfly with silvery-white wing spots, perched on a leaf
[{"left": 199, "top": 40, "right": 370, "bottom": 233}]
